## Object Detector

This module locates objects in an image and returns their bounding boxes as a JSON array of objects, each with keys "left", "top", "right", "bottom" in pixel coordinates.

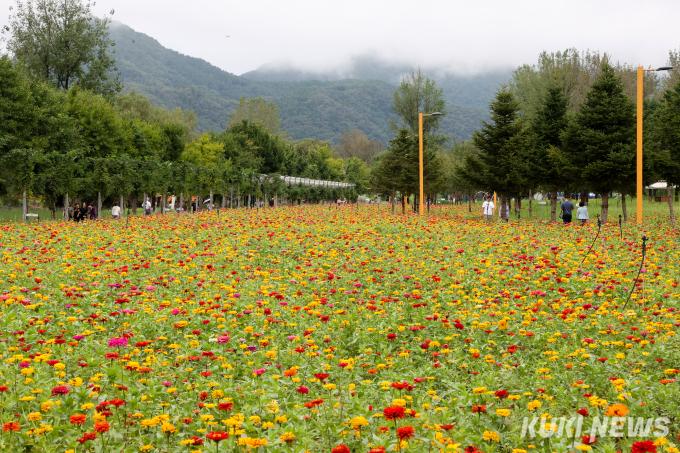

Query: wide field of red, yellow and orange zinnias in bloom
[{"left": 0, "top": 206, "right": 680, "bottom": 453}]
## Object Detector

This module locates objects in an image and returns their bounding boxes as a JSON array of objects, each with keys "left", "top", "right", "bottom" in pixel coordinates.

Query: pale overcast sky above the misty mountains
[{"left": 0, "top": 0, "right": 680, "bottom": 74}]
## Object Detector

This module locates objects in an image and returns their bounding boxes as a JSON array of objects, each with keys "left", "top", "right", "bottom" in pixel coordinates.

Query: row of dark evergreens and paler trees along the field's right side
[{"left": 372, "top": 49, "right": 680, "bottom": 221}]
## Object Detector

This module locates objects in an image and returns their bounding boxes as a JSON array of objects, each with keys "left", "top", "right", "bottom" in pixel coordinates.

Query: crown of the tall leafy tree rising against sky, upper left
[{"left": 3, "top": 0, "right": 121, "bottom": 97}]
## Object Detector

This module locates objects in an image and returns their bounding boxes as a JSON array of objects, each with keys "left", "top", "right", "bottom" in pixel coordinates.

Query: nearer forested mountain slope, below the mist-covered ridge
[{"left": 109, "top": 23, "right": 498, "bottom": 144}]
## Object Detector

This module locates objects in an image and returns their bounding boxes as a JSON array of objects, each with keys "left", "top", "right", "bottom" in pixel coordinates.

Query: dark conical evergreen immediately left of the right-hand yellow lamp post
[{"left": 562, "top": 62, "right": 636, "bottom": 222}]
